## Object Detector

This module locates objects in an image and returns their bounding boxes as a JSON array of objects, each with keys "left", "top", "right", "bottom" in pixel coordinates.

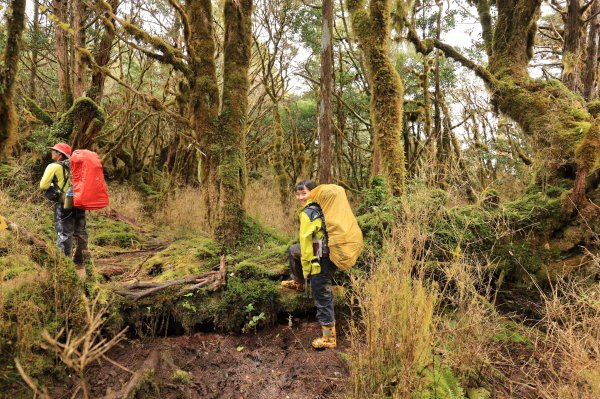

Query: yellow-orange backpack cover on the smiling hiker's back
[{"left": 310, "top": 184, "right": 363, "bottom": 270}]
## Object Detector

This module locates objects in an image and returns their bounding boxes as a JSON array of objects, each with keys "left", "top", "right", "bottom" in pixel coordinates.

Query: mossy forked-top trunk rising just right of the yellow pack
[{"left": 347, "top": 0, "right": 405, "bottom": 196}]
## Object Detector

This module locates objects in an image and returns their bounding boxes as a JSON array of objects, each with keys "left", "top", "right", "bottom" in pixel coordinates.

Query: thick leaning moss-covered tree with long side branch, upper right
[{"left": 409, "top": 0, "right": 600, "bottom": 211}]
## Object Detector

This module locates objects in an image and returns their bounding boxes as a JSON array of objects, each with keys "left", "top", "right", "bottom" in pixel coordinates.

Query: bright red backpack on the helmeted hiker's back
[{"left": 69, "top": 150, "right": 108, "bottom": 210}]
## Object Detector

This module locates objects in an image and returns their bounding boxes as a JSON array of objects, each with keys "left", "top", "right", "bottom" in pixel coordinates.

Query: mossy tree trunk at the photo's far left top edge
[{"left": 0, "top": 0, "right": 25, "bottom": 158}]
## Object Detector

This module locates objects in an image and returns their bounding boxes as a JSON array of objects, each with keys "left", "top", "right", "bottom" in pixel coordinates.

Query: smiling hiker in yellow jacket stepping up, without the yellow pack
[{"left": 281, "top": 180, "right": 337, "bottom": 349}]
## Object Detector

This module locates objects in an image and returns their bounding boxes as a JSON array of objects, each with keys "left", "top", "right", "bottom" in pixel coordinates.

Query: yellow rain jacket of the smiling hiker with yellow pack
[{"left": 298, "top": 200, "right": 323, "bottom": 279}]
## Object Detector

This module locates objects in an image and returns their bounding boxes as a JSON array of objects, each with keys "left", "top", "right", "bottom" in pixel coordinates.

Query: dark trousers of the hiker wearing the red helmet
[{"left": 54, "top": 202, "right": 88, "bottom": 264}]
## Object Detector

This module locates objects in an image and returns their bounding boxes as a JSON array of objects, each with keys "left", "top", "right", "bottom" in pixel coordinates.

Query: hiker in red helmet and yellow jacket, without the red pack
[{"left": 40, "top": 143, "right": 88, "bottom": 265}]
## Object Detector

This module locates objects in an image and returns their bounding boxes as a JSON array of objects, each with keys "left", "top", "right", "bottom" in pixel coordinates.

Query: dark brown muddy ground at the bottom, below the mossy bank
[{"left": 51, "top": 320, "right": 347, "bottom": 399}]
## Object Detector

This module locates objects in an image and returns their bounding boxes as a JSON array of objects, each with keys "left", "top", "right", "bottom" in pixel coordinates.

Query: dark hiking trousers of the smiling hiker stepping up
[{"left": 289, "top": 244, "right": 337, "bottom": 326}]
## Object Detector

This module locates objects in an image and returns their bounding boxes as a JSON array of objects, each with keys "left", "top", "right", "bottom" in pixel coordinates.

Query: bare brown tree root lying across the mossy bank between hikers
[{"left": 114, "top": 256, "right": 227, "bottom": 301}]
